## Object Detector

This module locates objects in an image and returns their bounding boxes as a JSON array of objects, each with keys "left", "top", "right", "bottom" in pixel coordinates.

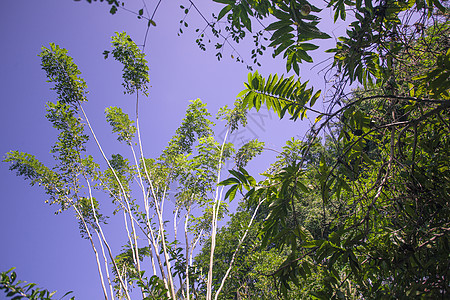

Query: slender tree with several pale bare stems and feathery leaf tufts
[{"left": 1, "top": 33, "right": 261, "bottom": 299}]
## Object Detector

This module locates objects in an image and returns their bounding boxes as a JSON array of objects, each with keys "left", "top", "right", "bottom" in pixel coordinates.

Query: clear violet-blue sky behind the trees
[{"left": 0, "top": 0, "right": 342, "bottom": 299}]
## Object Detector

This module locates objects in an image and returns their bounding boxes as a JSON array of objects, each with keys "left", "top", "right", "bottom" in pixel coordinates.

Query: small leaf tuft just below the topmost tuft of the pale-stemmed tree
[{"left": 105, "top": 107, "right": 136, "bottom": 145}]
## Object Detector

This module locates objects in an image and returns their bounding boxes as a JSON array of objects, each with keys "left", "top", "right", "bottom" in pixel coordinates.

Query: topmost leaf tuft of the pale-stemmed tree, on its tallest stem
[{"left": 104, "top": 32, "right": 150, "bottom": 95}]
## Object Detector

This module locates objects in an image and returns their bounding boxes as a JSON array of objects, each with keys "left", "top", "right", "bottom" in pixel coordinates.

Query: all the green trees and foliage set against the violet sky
[{"left": 0, "top": 0, "right": 450, "bottom": 300}]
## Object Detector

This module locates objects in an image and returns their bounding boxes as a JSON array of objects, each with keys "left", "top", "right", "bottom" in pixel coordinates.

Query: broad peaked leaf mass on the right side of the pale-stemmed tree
[{"left": 145, "top": 99, "right": 234, "bottom": 234}]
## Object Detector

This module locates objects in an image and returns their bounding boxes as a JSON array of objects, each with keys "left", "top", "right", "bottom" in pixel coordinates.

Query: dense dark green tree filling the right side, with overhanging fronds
[{"left": 212, "top": 1, "right": 450, "bottom": 299}]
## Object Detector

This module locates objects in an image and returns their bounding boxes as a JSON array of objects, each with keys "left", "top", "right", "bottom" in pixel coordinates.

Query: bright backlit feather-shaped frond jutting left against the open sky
[{"left": 238, "top": 72, "right": 320, "bottom": 120}]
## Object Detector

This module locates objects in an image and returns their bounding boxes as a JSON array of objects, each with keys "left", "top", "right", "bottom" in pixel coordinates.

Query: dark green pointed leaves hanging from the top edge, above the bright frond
[{"left": 209, "top": 0, "right": 330, "bottom": 75}]
